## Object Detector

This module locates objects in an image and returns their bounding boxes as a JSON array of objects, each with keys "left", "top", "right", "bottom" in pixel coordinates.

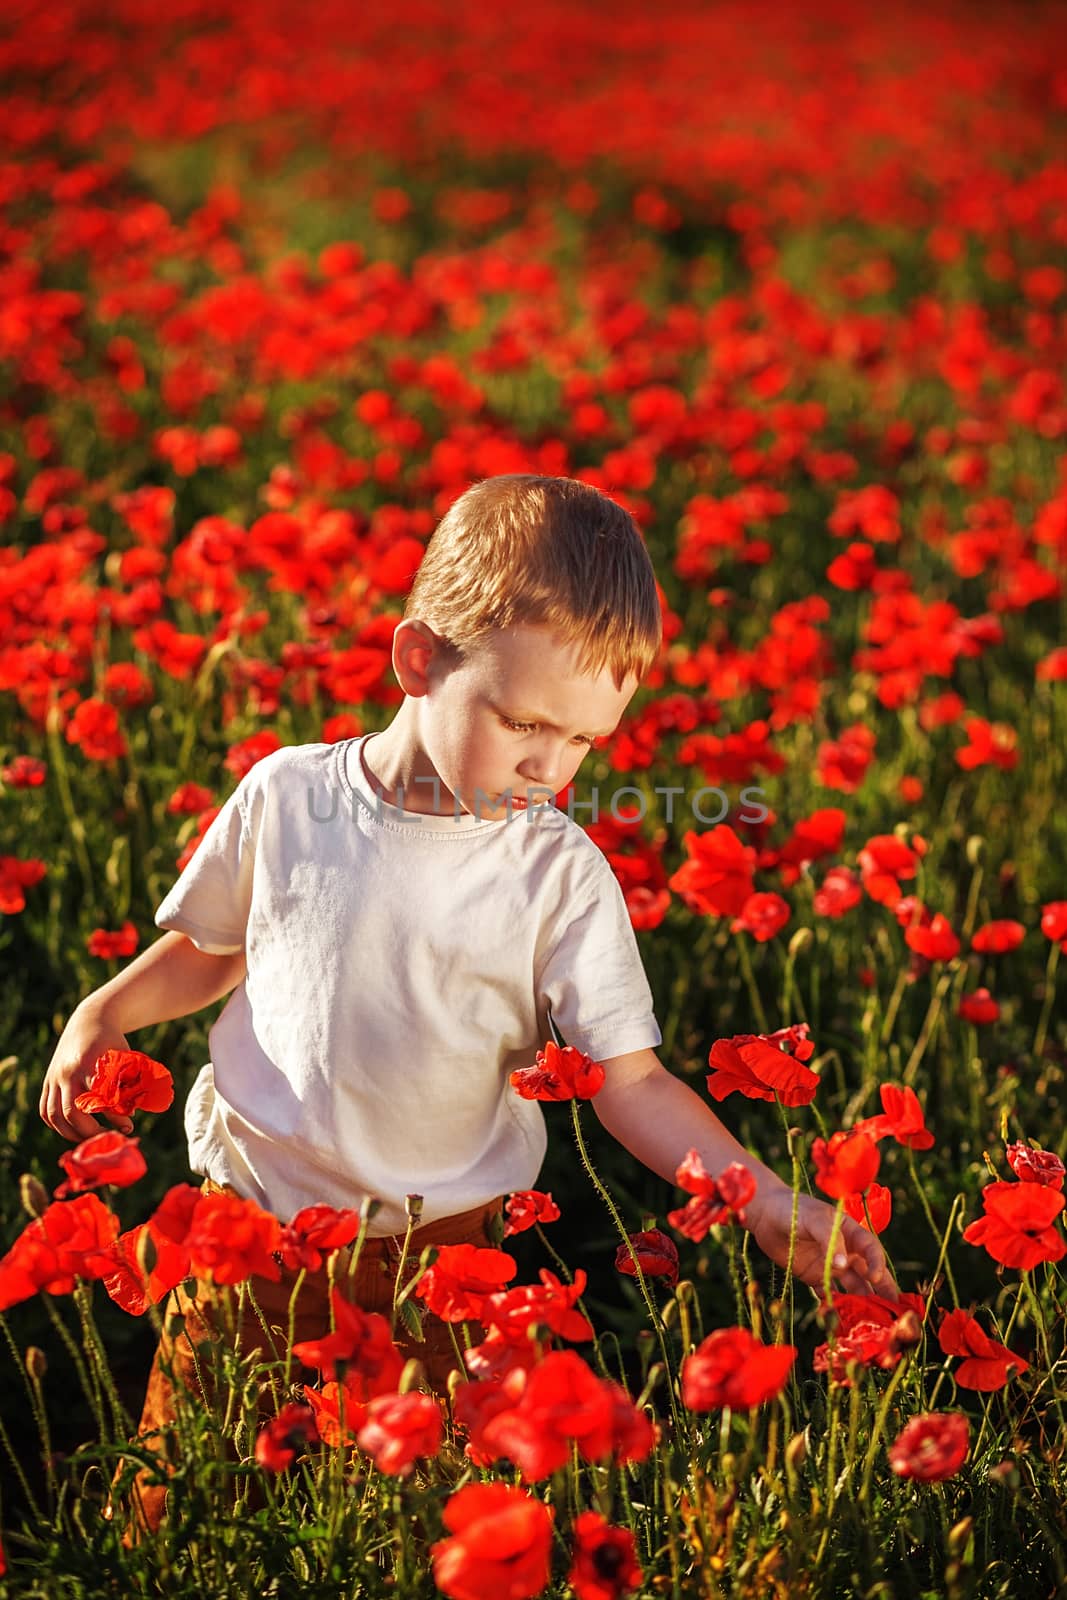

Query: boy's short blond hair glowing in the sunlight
[{"left": 403, "top": 474, "right": 662, "bottom": 688}]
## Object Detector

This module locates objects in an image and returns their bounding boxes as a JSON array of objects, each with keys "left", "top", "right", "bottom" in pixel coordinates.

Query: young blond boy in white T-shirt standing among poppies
[{"left": 42, "top": 475, "right": 893, "bottom": 1523}]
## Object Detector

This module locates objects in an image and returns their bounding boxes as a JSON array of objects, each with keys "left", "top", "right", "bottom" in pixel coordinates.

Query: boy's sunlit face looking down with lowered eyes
[{"left": 418, "top": 622, "right": 637, "bottom": 821}]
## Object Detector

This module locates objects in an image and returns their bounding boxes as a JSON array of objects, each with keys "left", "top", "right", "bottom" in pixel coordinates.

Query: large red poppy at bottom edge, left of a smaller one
[{"left": 430, "top": 1483, "right": 553, "bottom": 1600}]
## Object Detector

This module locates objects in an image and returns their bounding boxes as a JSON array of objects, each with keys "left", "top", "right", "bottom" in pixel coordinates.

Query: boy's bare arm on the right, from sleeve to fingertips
[{"left": 592, "top": 1050, "right": 896, "bottom": 1299}]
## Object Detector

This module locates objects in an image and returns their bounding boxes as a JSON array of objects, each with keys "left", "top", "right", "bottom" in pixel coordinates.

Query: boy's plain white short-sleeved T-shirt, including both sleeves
[{"left": 155, "top": 736, "right": 662, "bottom": 1235}]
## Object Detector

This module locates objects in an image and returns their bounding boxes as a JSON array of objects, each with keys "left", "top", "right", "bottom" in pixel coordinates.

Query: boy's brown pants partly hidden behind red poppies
[{"left": 115, "top": 1178, "right": 502, "bottom": 1544}]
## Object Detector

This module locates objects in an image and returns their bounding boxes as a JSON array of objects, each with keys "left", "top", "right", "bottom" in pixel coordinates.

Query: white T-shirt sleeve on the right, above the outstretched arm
[{"left": 537, "top": 861, "right": 662, "bottom": 1061}]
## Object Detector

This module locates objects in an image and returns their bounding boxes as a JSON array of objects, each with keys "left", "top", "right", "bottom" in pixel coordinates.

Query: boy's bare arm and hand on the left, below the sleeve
[{"left": 40, "top": 933, "right": 246, "bottom": 1142}]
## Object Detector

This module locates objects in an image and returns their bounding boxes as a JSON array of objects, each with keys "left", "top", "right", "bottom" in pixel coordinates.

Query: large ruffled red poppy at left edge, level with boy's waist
[{"left": 0, "top": 1195, "right": 118, "bottom": 1310}]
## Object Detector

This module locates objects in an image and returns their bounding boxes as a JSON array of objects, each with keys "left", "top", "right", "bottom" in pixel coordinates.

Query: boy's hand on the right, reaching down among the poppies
[{"left": 747, "top": 1184, "right": 897, "bottom": 1299}]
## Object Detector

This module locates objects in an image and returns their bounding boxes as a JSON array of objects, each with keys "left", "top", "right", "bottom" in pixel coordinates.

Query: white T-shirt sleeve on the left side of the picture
[{"left": 155, "top": 768, "right": 258, "bottom": 955}]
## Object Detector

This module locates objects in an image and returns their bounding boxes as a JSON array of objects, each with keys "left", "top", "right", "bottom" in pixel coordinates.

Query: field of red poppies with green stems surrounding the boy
[{"left": 0, "top": 0, "right": 1067, "bottom": 1600}]
